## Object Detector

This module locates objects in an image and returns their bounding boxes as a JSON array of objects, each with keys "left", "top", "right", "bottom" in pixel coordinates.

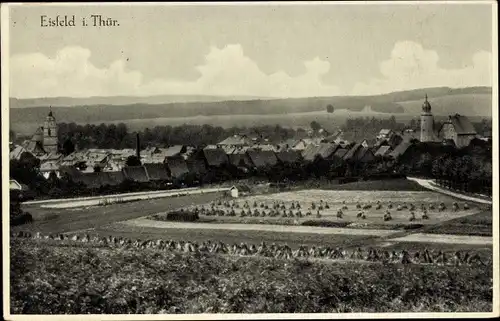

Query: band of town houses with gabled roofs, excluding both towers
[{"left": 5, "top": 130, "right": 446, "bottom": 188}]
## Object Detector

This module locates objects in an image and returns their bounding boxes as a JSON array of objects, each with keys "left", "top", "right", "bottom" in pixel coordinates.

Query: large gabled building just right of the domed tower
[{"left": 438, "top": 114, "right": 477, "bottom": 148}]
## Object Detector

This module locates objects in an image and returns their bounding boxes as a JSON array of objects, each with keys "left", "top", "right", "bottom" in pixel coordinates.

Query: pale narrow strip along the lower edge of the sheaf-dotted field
[{"left": 120, "top": 218, "right": 396, "bottom": 236}]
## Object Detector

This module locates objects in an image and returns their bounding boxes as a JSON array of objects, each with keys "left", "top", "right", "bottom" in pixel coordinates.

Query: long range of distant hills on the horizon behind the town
[{"left": 10, "top": 87, "right": 492, "bottom": 131}]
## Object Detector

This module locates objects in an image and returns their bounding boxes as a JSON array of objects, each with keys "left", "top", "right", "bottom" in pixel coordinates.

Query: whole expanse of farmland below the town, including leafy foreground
[{"left": 11, "top": 182, "right": 493, "bottom": 314}]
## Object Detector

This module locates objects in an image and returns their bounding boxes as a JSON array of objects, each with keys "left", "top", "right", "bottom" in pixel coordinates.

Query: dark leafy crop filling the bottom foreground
[{"left": 11, "top": 240, "right": 492, "bottom": 314}]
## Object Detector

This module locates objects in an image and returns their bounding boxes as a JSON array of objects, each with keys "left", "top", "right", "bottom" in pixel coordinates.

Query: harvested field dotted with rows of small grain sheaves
[{"left": 151, "top": 190, "right": 480, "bottom": 229}]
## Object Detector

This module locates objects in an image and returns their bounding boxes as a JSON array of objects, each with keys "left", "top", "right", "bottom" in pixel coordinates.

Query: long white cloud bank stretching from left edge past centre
[{"left": 10, "top": 44, "right": 338, "bottom": 98}]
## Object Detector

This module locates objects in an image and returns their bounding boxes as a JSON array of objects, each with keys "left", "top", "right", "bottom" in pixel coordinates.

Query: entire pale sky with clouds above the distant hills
[{"left": 5, "top": 3, "right": 496, "bottom": 98}]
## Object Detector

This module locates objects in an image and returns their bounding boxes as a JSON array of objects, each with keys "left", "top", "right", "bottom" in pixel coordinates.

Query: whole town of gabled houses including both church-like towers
[{"left": 10, "top": 98, "right": 490, "bottom": 187}]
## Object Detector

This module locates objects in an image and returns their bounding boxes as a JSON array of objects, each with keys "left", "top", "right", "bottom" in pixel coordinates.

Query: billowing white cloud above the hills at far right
[{"left": 351, "top": 41, "right": 492, "bottom": 95}]
